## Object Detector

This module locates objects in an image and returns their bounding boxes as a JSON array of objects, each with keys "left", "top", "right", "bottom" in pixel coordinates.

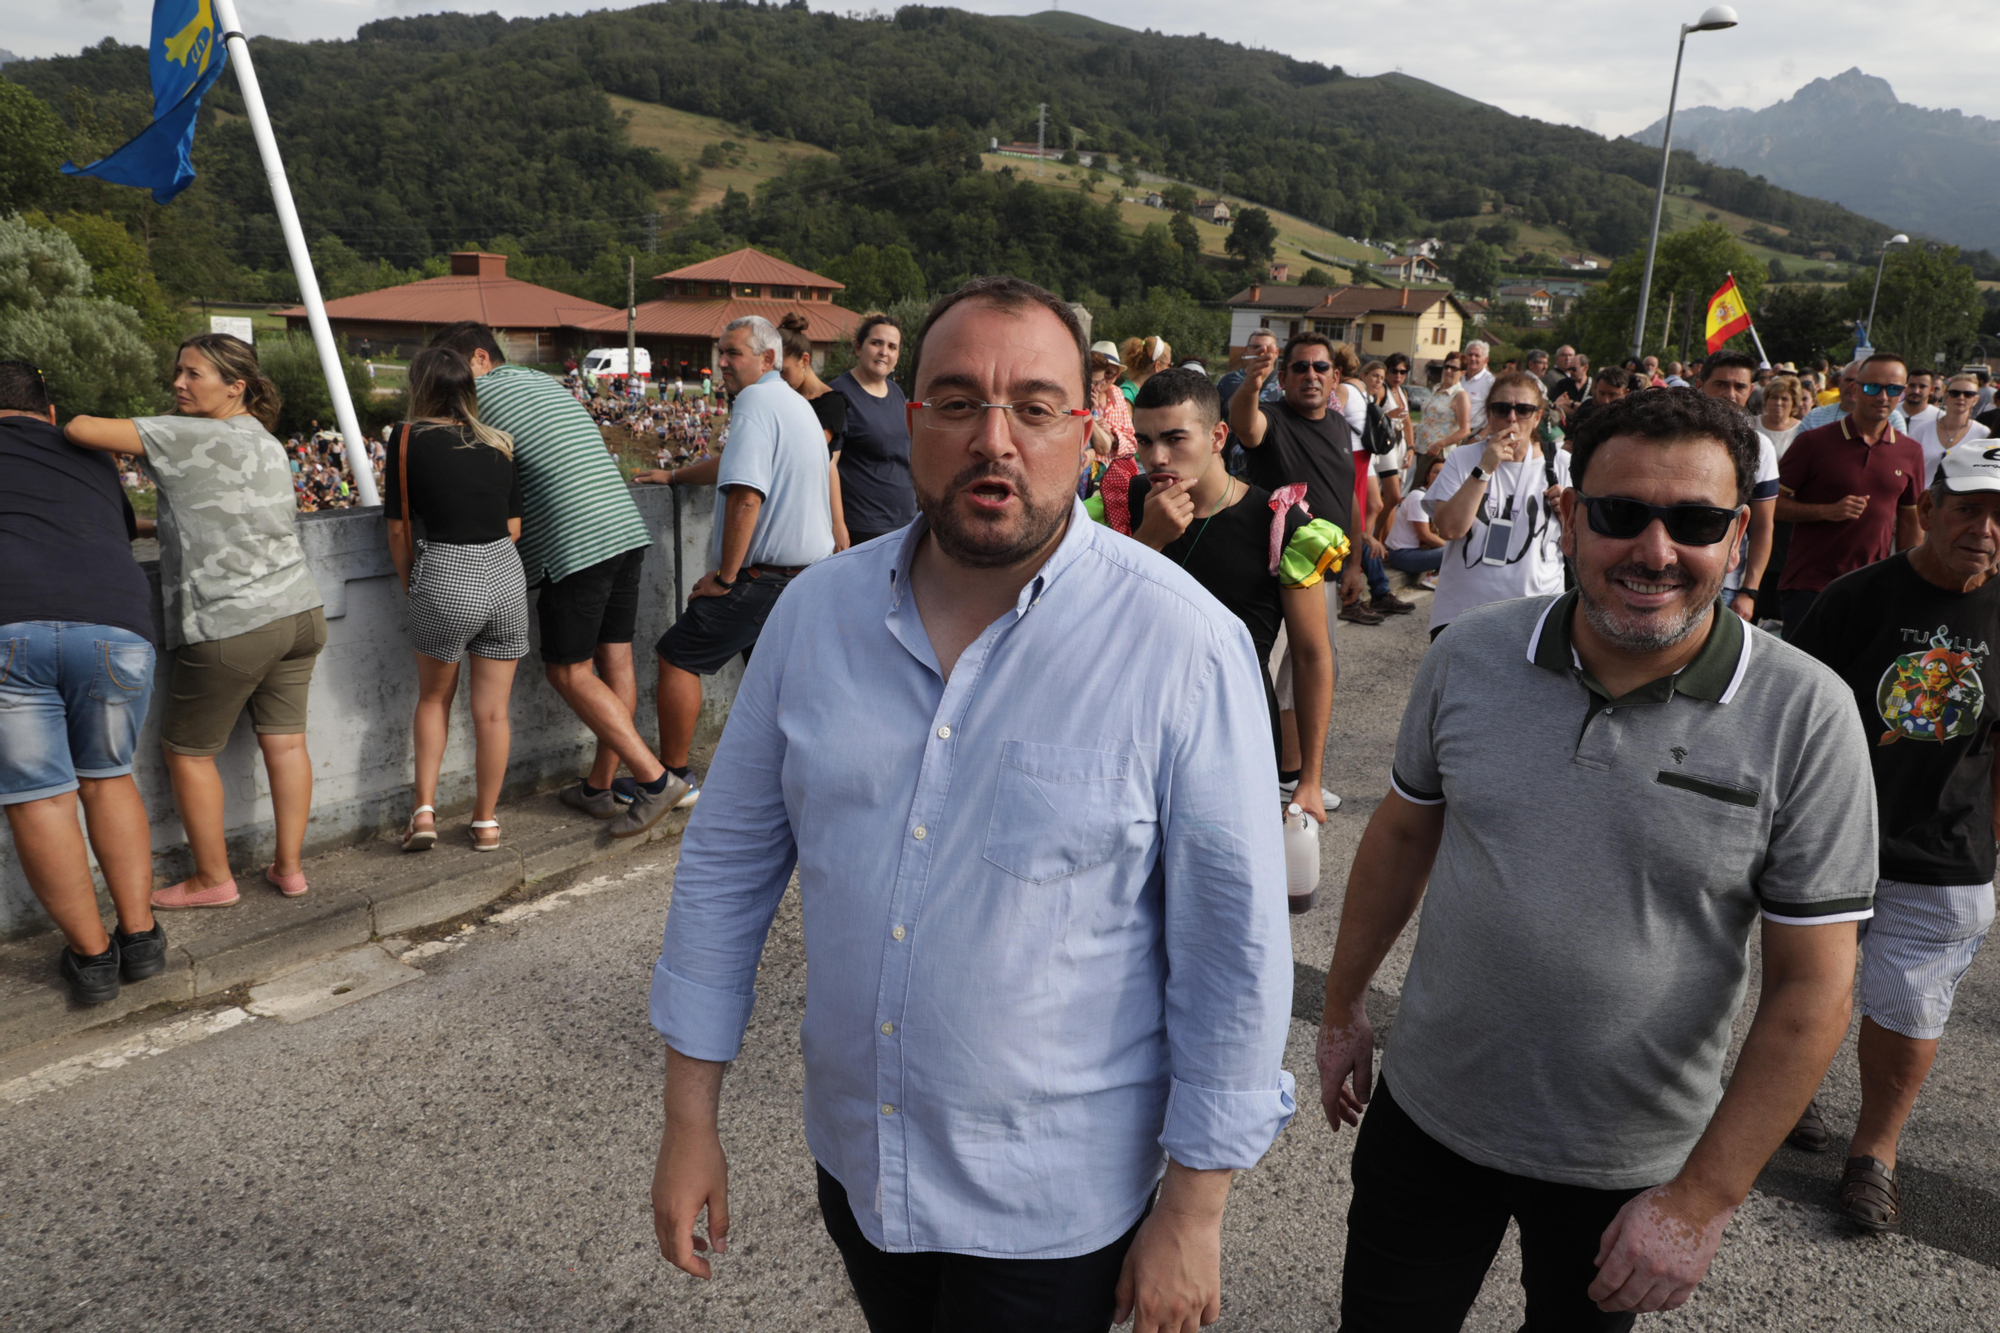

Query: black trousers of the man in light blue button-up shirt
[{"left": 814, "top": 1163, "right": 1152, "bottom": 1333}]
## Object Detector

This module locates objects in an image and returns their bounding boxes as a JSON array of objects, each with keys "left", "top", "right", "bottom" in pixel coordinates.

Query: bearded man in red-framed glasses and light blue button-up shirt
[{"left": 652, "top": 278, "right": 1292, "bottom": 1333}]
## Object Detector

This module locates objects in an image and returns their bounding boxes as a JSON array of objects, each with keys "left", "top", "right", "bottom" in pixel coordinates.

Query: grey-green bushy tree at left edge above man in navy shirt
[{"left": 0, "top": 216, "right": 166, "bottom": 416}]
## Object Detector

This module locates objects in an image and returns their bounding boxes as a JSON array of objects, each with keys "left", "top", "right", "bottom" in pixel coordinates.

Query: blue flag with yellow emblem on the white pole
[{"left": 62, "top": 0, "right": 230, "bottom": 204}]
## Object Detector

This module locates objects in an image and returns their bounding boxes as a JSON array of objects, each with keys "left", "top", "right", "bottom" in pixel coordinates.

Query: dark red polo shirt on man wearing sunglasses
[{"left": 1778, "top": 416, "right": 1924, "bottom": 592}]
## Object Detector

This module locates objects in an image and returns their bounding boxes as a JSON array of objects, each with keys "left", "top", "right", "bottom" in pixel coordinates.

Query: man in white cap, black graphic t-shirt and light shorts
[{"left": 1790, "top": 440, "right": 2000, "bottom": 1231}]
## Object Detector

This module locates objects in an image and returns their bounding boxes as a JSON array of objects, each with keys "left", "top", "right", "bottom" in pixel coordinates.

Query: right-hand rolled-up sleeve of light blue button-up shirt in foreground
[{"left": 1160, "top": 624, "right": 1296, "bottom": 1171}]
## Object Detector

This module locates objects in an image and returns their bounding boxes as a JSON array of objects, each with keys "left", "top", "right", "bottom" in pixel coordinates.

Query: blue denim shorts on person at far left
[{"left": 0, "top": 620, "right": 154, "bottom": 805}]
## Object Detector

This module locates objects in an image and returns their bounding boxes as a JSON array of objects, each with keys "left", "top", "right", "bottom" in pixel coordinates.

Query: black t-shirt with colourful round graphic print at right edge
[{"left": 1792, "top": 552, "right": 2000, "bottom": 885}]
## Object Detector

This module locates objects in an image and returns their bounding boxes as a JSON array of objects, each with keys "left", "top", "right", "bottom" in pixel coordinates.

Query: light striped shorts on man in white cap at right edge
[{"left": 1854, "top": 879, "right": 1994, "bottom": 1041}]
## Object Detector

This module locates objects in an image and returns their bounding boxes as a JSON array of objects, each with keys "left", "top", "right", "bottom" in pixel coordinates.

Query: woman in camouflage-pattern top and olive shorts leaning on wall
[{"left": 64, "top": 334, "right": 326, "bottom": 909}]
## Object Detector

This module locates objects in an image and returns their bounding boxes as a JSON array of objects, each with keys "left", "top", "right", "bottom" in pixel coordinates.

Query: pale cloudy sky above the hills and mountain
[{"left": 15, "top": 0, "right": 2000, "bottom": 134}]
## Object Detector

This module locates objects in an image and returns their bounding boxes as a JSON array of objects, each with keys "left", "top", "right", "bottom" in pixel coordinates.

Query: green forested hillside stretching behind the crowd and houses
[{"left": 4, "top": 0, "right": 1920, "bottom": 300}]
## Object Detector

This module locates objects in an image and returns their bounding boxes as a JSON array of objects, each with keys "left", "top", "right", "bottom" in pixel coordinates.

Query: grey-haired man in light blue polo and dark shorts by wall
[{"left": 632, "top": 314, "right": 834, "bottom": 835}]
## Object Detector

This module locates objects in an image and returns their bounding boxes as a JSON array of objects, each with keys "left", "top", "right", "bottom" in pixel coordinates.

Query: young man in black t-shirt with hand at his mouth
[{"left": 1130, "top": 368, "right": 1348, "bottom": 823}]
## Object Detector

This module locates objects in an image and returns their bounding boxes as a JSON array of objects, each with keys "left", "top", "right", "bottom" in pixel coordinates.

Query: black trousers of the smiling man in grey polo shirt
[{"left": 1340, "top": 1081, "right": 1640, "bottom": 1333}]
